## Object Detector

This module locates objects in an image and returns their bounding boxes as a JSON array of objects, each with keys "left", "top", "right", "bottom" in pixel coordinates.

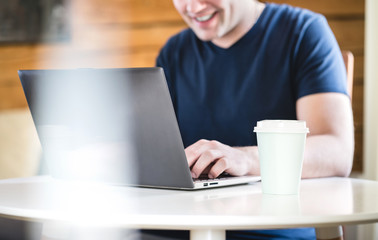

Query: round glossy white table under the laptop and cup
[{"left": 0, "top": 177, "right": 378, "bottom": 239}]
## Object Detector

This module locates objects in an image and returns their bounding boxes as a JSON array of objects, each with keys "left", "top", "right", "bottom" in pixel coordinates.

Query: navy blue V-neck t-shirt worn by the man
[{"left": 157, "top": 4, "right": 347, "bottom": 239}]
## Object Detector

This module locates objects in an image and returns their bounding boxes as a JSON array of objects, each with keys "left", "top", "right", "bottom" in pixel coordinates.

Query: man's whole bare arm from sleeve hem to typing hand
[{"left": 185, "top": 93, "right": 354, "bottom": 178}]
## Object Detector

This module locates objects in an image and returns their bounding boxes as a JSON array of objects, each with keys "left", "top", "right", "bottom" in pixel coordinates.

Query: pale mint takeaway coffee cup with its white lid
[{"left": 254, "top": 120, "right": 309, "bottom": 194}]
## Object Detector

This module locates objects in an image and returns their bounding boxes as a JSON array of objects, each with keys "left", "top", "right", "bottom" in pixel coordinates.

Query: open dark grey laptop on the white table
[{"left": 18, "top": 67, "right": 260, "bottom": 190}]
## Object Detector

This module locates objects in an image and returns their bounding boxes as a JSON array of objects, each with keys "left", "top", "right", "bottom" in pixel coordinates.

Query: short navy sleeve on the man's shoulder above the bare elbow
[{"left": 294, "top": 15, "right": 347, "bottom": 99}]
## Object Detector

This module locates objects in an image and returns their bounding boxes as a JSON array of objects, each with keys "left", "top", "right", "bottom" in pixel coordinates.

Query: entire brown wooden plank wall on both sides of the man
[{"left": 0, "top": 0, "right": 365, "bottom": 171}]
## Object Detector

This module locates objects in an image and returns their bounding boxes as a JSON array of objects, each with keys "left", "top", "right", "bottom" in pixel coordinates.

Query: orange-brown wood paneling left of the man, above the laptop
[{"left": 0, "top": 0, "right": 186, "bottom": 109}]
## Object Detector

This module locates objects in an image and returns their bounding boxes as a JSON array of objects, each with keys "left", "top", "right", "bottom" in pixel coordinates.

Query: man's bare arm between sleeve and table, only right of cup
[{"left": 297, "top": 93, "right": 354, "bottom": 178}]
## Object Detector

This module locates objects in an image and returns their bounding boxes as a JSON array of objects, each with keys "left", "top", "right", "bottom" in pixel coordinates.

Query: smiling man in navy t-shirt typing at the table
[{"left": 152, "top": 0, "right": 354, "bottom": 239}]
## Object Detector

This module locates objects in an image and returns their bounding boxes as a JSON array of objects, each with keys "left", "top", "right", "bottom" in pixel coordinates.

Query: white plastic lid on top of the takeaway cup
[{"left": 253, "top": 120, "right": 309, "bottom": 133}]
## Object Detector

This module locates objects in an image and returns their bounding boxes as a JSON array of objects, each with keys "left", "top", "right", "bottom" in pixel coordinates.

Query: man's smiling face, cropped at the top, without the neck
[{"left": 173, "top": 0, "right": 244, "bottom": 41}]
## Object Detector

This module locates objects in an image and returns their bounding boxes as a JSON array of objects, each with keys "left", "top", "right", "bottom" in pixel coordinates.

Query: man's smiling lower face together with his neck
[{"left": 173, "top": 0, "right": 265, "bottom": 48}]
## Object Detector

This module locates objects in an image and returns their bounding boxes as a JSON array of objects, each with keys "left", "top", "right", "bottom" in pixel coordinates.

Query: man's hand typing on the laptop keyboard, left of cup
[{"left": 185, "top": 140, "right": 258, "bottom": 178}]
